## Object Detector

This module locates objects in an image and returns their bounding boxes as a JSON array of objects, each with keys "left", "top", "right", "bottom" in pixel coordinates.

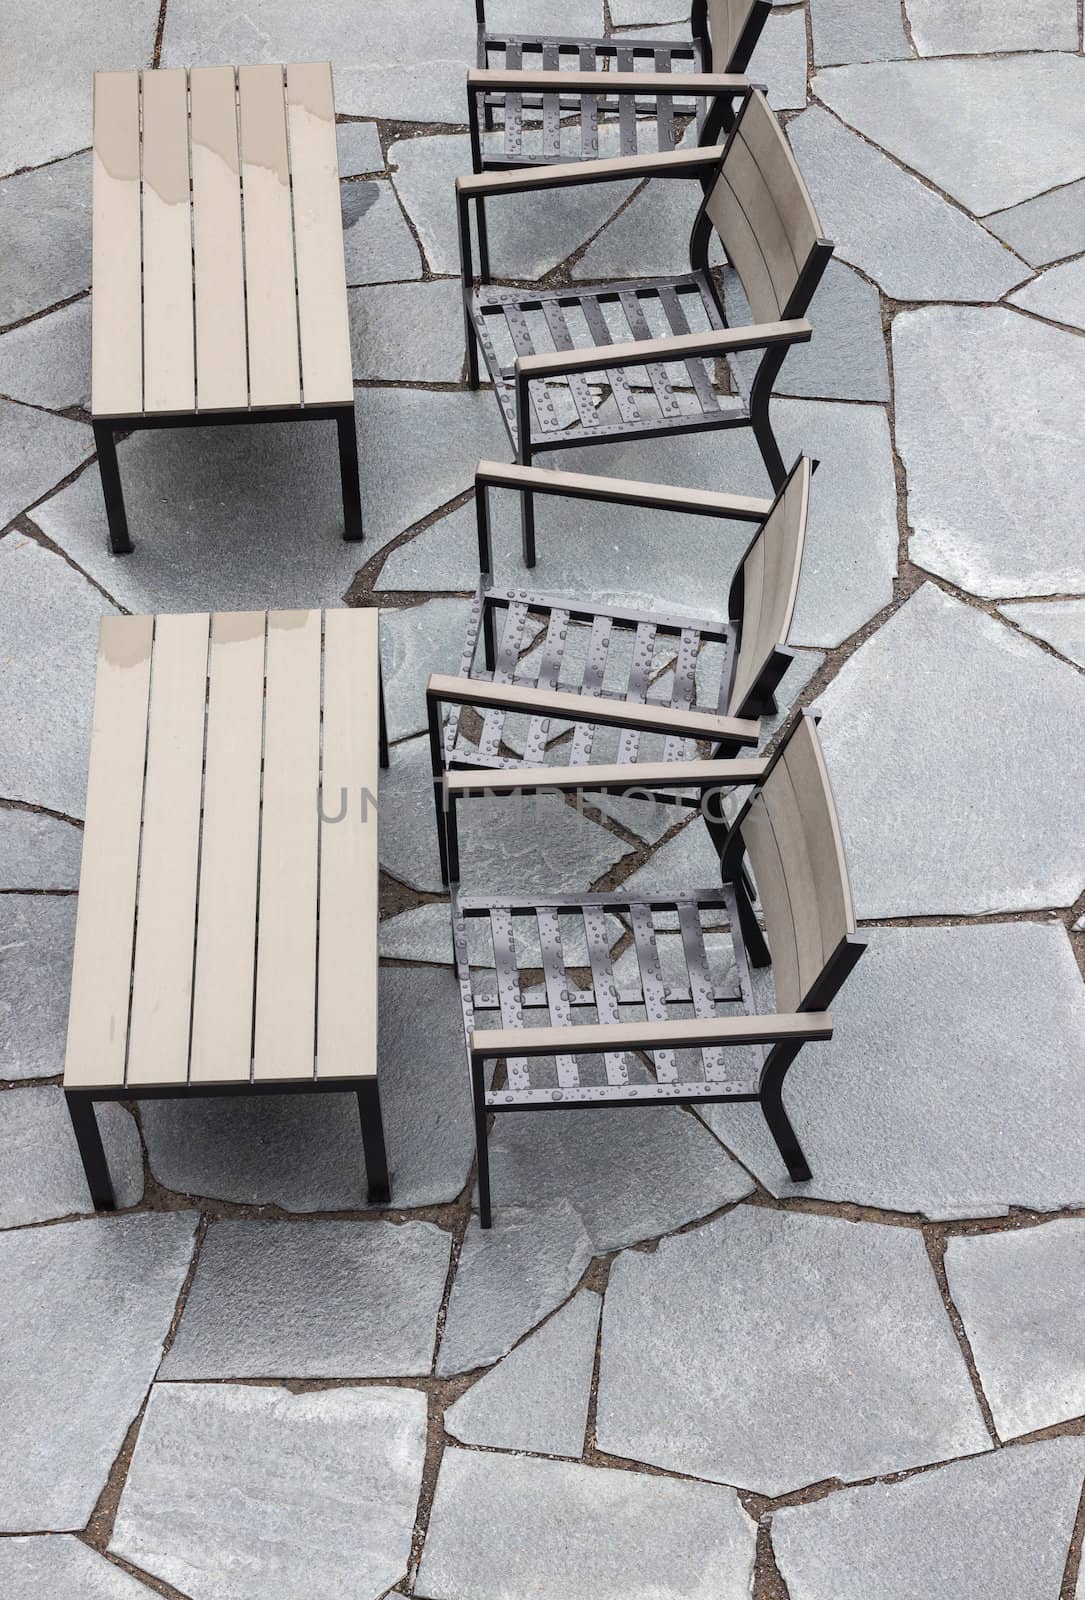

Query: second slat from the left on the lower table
[{"left": 126, "top": 611, "right": 210, "bottom": 1085}]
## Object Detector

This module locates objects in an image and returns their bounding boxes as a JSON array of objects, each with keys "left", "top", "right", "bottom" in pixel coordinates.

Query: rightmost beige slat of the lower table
[{"left": 317, "top": 610, "right": 379, "bottom": 1078}]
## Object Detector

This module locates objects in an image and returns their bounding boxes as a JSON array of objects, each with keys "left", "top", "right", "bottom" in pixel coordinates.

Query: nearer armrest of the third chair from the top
[{"left": 426, "top": 674, "right": 760, "bottom": 744}]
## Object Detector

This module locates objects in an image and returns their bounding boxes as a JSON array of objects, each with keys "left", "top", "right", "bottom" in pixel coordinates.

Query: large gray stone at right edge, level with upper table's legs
[{"left": 893, "top": 306, "right": 1085, "bottom": 598}]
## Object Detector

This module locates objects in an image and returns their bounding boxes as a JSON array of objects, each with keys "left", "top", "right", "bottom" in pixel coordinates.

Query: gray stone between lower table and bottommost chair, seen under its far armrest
[{"left": 381, "top": 739, "right": 631, "bottom": 894}]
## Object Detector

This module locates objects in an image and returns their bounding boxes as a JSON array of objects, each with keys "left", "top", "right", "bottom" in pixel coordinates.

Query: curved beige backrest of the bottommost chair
[{"left": 738, "top": 712, "right": 855, "bottom": 1011}]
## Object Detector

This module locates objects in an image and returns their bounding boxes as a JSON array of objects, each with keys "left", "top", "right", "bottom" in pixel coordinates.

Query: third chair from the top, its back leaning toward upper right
[{"left": 426, "top": 456, "right": 816, "bottom": 883}]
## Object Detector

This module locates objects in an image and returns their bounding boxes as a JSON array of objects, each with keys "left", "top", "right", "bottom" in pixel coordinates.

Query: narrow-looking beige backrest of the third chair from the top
[{"left": 720, "top": 456, "right": 815, "bottom": 717}]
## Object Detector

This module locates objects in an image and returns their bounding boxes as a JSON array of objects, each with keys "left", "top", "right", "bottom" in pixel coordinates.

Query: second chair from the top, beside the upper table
[{"left": 456, "top": 90, "right": 832, "bottom": 566}]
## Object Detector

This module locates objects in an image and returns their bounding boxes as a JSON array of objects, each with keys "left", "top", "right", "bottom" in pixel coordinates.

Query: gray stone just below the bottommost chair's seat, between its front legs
[{"left": 490, "top": 1106, "right": 754, "bottom": 1254}]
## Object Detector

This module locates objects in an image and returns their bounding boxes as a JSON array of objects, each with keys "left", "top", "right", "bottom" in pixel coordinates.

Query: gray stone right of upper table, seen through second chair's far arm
[{"left": 389, "top": 134, "right": 634, "bottom": 278}]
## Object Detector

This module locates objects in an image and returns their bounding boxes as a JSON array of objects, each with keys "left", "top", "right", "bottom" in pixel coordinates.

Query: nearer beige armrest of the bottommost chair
[{"left": 470, "top": 1011, "right": 832, "bottom": 1061}]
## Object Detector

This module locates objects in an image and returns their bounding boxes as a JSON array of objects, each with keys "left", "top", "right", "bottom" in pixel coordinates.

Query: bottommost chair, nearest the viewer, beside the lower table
[{"left": 451, "top": 712, "right": 866, "bottom": 1227}]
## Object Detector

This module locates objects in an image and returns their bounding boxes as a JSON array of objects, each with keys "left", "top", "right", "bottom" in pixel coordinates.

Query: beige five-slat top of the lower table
[{"left": 64, "top": 610, "right": 379, "bottom": 1088}]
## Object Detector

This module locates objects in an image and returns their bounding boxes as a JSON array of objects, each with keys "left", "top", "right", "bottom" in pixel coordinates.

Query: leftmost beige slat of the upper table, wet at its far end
[{"left": 91, "top": 72, "right": 142, "bottom": 416}]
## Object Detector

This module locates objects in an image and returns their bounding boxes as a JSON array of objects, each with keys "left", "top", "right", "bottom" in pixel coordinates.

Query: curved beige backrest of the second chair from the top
[{"left": 706, "top": 90, "right": 821, "bottom": 323}]
